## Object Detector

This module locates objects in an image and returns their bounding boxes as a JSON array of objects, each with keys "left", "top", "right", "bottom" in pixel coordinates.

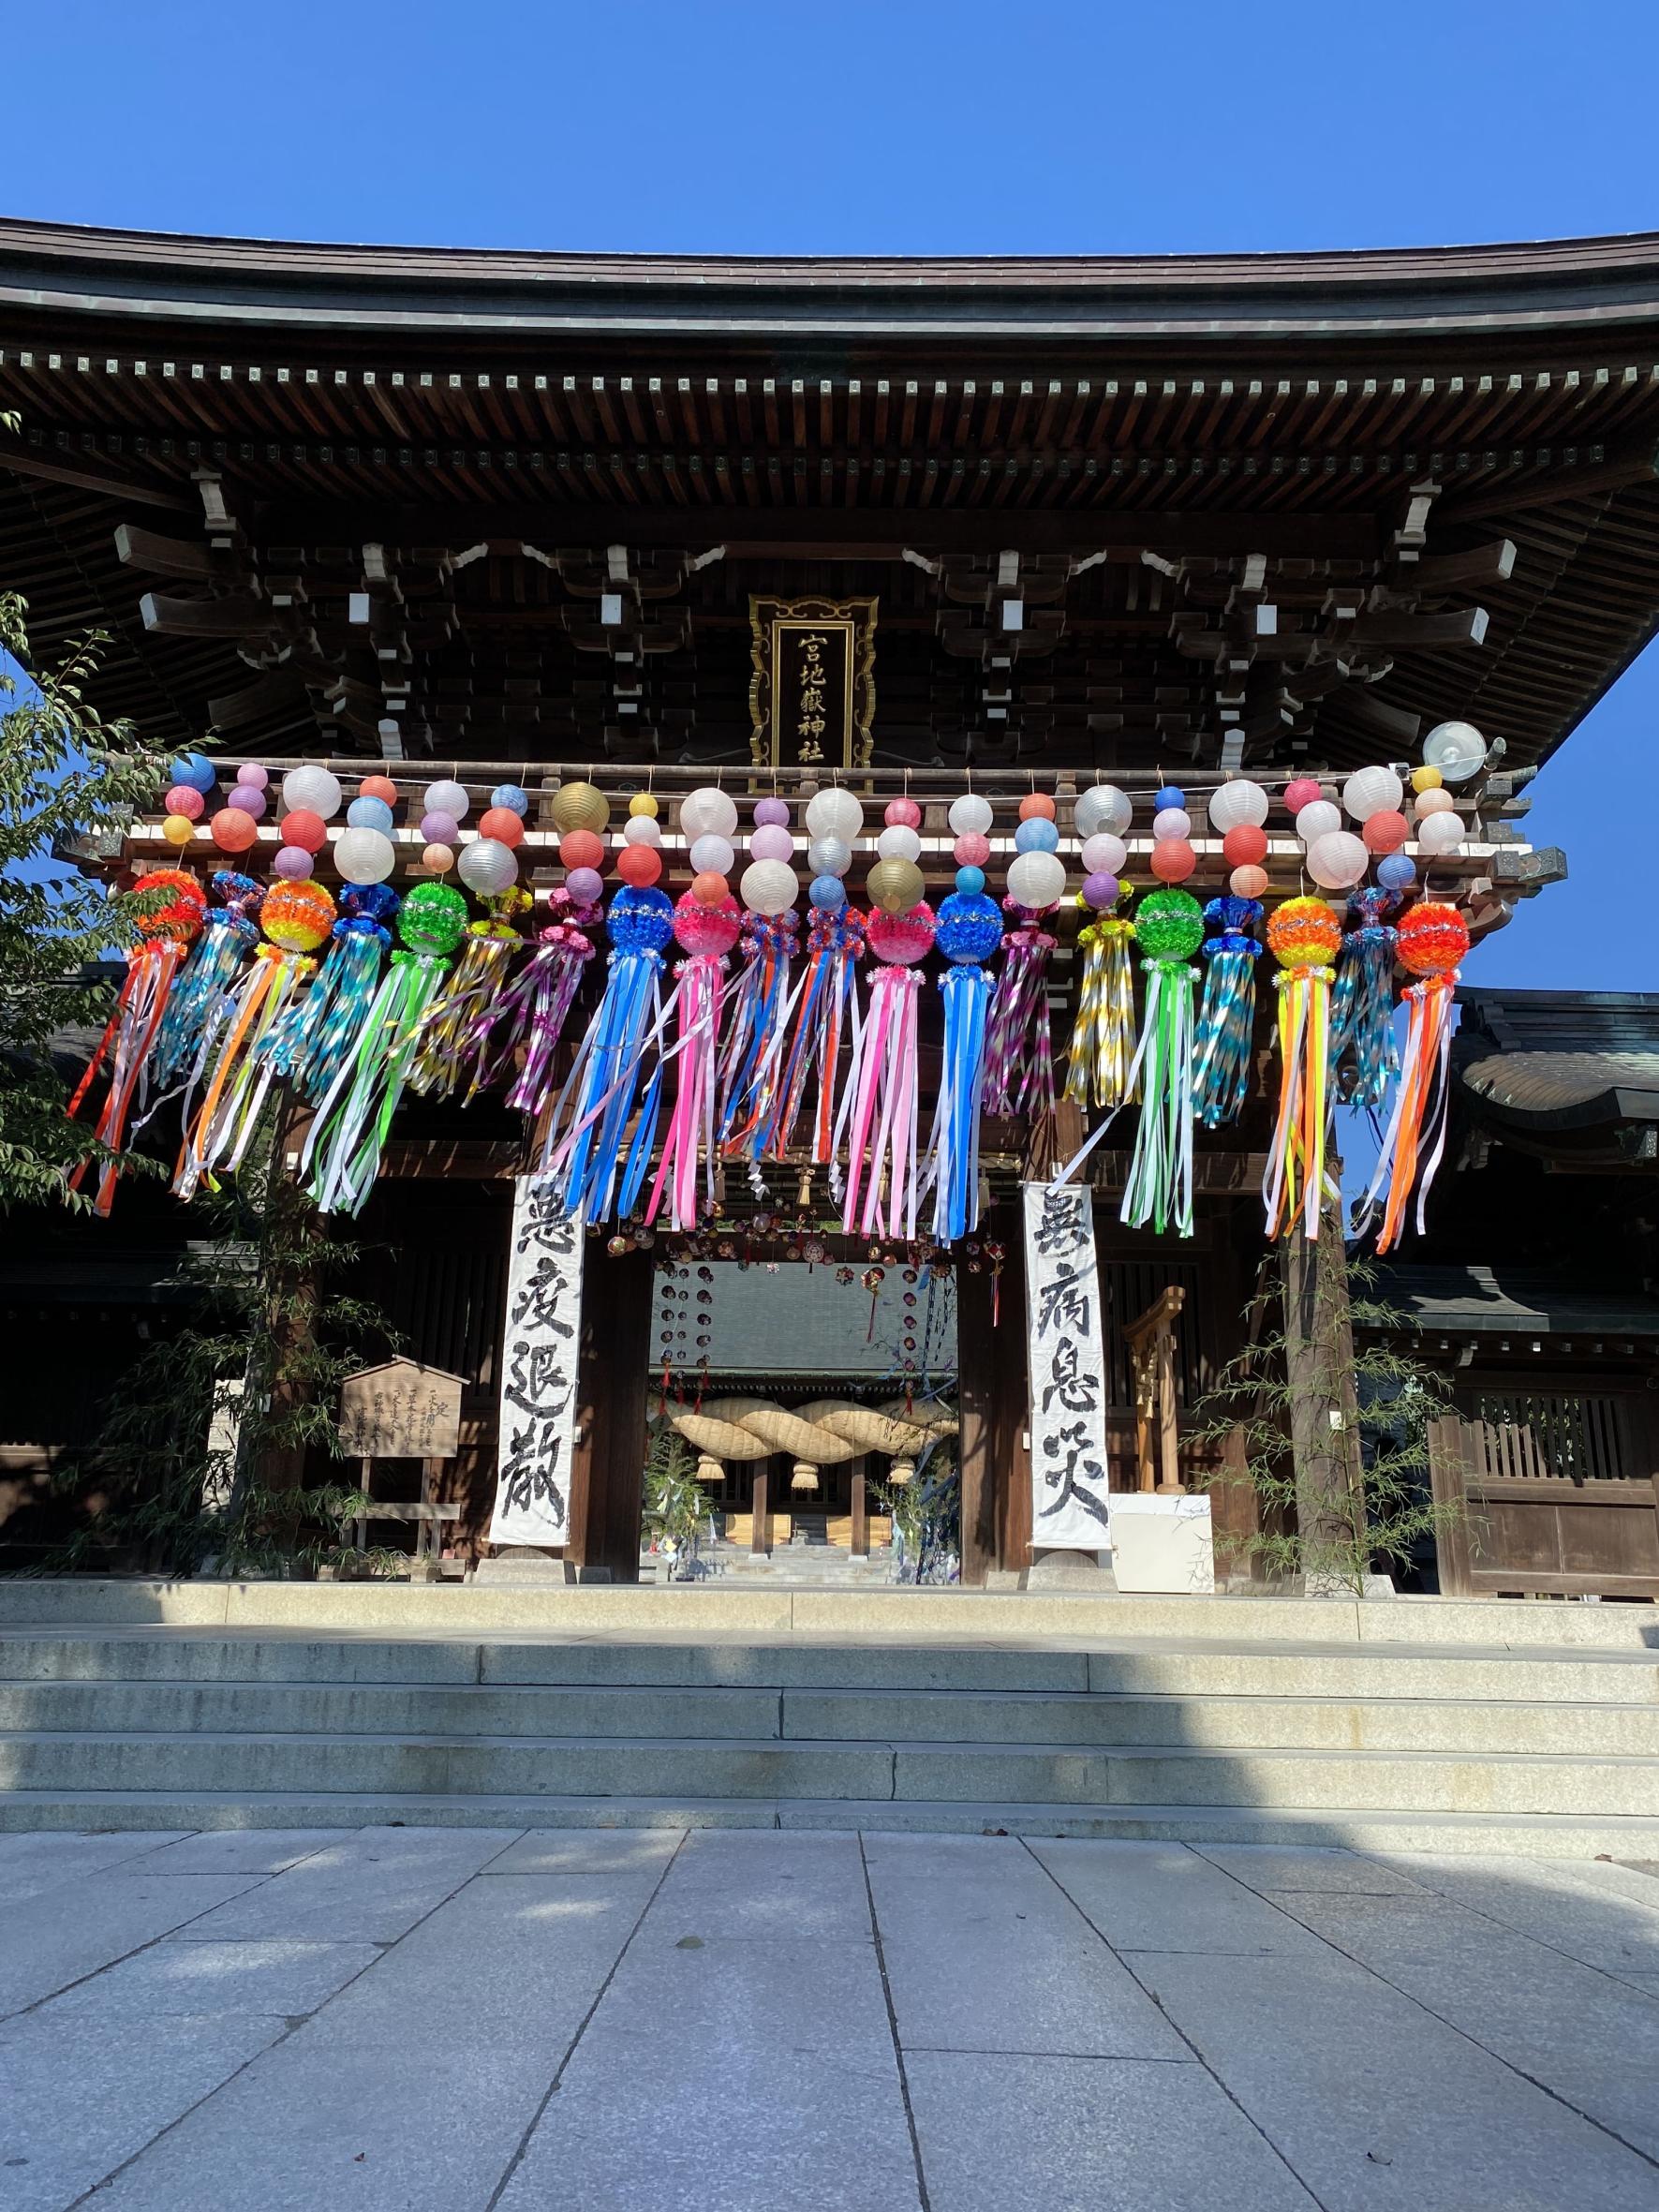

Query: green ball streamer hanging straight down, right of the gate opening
[{"left": 1121, "top": 889, "right": 1204, "bottom": 1237}]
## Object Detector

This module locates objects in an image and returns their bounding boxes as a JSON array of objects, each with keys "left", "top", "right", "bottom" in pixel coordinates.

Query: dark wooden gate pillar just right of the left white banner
[{"left": 564, "top": 1239, "right": 653, "bottom": 1581}]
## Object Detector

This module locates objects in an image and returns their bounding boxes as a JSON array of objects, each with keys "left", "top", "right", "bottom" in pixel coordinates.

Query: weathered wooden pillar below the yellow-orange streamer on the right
[{"left": 1279, "top": 1206, "right": 1365, "bottom": 1595}]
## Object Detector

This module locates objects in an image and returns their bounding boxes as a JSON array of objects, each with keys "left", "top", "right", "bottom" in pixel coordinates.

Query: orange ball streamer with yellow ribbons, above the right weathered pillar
[{"left": 1261, "top": 898, "right": 1342, "bottom": 1241}]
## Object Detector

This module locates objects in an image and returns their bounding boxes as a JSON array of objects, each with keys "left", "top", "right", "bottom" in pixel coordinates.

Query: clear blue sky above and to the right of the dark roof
[{"left": 0, "top": 0, "right": 1659, "bottom": 988}]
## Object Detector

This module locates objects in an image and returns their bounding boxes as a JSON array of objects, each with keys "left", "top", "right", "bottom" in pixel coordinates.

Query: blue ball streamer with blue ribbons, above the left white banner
[{"left": 542, "top": 884, "right": 674, "bottom": 1224}]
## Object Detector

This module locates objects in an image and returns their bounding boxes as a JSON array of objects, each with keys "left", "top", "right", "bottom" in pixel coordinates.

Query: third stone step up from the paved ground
[{"left": 0, "top": 1670, "right": 1659, "bottom": 1760}]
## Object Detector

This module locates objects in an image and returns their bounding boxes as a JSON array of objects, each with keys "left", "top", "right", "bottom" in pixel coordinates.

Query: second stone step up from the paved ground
[{"left": 0, "top": 1730, "right": 1659, "bottom": 1819}]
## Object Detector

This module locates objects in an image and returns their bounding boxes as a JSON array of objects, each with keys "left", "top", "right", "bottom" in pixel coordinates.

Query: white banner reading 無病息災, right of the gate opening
[{"left": 1022, "top": 1183, "right": 1110, "bottom": 1551}]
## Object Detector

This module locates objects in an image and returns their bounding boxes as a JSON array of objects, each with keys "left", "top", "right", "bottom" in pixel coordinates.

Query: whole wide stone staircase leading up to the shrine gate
[{"left": 0, "top": 1593, "right": 1659, "bottom": 1858}]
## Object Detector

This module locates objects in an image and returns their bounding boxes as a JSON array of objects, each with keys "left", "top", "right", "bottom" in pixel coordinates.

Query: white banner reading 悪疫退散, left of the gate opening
[{"left": 489, "top": 1175, "right": 584, "bottom": 1546}]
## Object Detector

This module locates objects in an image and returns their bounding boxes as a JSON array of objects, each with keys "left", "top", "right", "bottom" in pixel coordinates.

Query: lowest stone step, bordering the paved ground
[{"left": 0, "top": 1789, "right": 1659, "bottom": 1861}]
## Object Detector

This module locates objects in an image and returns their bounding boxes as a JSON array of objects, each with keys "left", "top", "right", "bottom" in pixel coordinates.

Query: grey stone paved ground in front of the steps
[{"left": 0, "top": 1830, "right": 1659, "bottom": 2212}]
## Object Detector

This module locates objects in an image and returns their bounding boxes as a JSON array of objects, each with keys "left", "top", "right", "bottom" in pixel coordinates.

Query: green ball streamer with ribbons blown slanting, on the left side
[{"left": 301, "top": 883, "right": 467, "bottom": 1214}]
